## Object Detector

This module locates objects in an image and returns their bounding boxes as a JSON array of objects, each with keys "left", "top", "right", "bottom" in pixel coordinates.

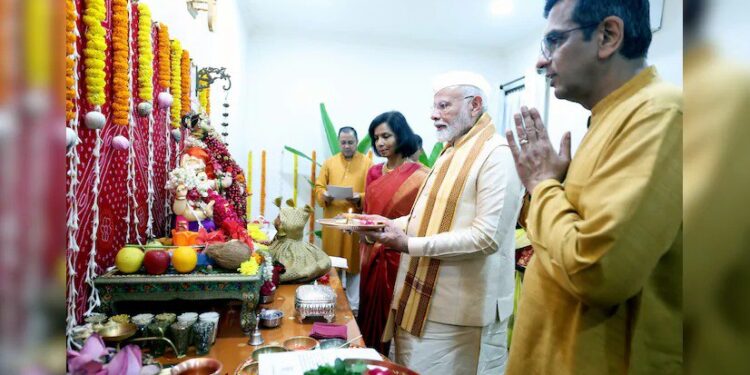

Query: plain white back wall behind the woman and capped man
[{"left": 236, "top": 35, "right": 502, "bottom": 225}]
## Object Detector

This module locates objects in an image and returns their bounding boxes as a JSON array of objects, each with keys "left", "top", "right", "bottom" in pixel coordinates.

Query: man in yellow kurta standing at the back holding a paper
[{"left": 315, "top": 126, "right": 372, "bottom": 310}]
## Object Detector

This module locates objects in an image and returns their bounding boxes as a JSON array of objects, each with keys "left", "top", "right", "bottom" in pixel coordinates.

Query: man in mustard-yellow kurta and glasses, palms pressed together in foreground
[{"left": 506, "top": 0, "right": 682, "bottom": 374}]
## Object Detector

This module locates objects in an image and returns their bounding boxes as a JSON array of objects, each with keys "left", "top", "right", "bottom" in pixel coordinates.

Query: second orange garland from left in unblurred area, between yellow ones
[{"left": 112, "top": 0, "right": 131, "bottom": 126}]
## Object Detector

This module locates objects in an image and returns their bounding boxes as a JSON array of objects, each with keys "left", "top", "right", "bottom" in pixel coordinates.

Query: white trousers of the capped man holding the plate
[{"left": 394, "top": 319, "right": 508, "bottom": 375}]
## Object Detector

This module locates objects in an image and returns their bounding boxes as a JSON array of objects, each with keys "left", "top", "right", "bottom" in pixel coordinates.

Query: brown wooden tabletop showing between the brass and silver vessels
[{"left": 152, "top": 268, "right": 365, "bottom": 375}]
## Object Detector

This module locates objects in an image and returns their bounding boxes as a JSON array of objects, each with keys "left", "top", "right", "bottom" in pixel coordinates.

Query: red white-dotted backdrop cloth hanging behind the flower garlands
[{"left": 67, "top": 0, "right": 184, "bottom": 321}]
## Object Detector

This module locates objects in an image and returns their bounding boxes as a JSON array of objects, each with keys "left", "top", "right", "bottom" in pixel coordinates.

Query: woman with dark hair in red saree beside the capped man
[{"left": 357, "top": 111, "right": 428, "bottom": 355}]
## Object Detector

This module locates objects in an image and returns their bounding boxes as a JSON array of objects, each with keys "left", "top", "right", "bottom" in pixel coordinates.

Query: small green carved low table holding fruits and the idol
[{"left": 94, "top": 270, "right": 263, "bottom": 332}]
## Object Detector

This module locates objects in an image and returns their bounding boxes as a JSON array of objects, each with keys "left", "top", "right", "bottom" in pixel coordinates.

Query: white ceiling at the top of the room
[{"left": 237, "top": 0, "right": 546, "bottom": 52}]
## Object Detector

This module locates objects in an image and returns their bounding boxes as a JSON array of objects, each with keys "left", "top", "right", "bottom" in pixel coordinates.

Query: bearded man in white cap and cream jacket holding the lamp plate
[{"left": 367, "top": 72, "right": 523, "bottom": 374}]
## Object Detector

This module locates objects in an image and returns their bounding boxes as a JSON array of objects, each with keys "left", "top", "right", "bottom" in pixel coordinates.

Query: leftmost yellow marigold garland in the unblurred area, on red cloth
[{"left": 83, "top": 0, "right": 107, "bottom": 106}]
